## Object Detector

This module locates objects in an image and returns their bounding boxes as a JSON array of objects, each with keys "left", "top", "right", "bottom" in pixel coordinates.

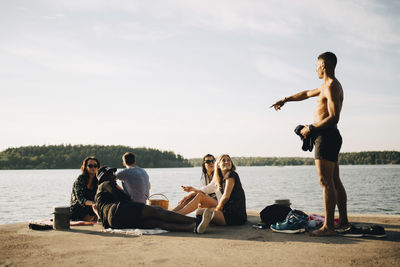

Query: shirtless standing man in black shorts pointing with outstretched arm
[{"left": 271, "top": 52, "right": 349, "bottom": 236}]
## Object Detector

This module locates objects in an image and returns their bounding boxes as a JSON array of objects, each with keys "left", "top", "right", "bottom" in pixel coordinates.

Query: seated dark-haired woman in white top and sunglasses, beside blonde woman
[{"left": 172, "top": 154, "right": 218, "bottom": 214}]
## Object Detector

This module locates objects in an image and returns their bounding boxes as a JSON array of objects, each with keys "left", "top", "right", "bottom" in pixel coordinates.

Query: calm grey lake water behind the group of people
[{"left": 0, "top": 165, "right": 400, "bottom": 224}]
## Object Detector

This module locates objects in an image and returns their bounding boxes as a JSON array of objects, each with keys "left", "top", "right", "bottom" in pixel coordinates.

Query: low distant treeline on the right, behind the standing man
[{"left": 189, "top": 151, "right": 400, "bottom": 166}]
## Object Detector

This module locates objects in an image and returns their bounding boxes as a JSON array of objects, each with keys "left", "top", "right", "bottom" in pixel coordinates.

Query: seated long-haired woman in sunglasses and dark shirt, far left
[{"left": 70, "top": 156, "right": 100, "bottom": 221}]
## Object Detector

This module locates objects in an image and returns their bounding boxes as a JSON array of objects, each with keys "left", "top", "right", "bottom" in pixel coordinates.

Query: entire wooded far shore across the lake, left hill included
[{"left": 0, "top": 145, "right": 400, "bottom": 170}]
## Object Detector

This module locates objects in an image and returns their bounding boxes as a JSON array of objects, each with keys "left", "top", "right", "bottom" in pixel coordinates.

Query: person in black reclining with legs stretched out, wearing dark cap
[{"left": 95, "top": 167, "right": 209, "bottom": 233}]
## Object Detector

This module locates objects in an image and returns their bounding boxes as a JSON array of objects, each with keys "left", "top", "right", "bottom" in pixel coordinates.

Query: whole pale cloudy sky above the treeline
[{"left": 0, "top": 0, "right": 400, "bottom": 158}]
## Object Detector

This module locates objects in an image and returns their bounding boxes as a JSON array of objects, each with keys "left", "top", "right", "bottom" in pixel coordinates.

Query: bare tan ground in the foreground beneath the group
[{"left": 0, "top": 211, "right": 400, "bottom": 266}]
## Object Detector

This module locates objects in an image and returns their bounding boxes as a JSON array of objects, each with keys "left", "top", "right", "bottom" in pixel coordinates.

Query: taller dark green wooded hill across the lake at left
[{"left": 0, "top": 145, "right": 192, "bottom": 170}]
